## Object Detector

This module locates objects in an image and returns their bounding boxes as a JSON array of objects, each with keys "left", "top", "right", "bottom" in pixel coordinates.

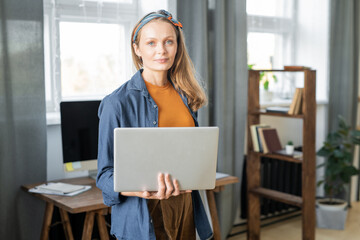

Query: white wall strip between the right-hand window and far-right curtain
[{"left": 295, "top": 0, "right": 330, "bottom": 196}]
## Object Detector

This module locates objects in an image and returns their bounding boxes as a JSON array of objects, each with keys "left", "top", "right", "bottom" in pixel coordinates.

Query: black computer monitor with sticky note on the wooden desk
[{"left": 60, "top": 101, "right": 100, "bottom": 178}]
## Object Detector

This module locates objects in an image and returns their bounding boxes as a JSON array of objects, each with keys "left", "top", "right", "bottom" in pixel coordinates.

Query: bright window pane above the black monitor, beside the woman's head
[{"left": 60, "top": 22, "right": 126, "bottom": 98}]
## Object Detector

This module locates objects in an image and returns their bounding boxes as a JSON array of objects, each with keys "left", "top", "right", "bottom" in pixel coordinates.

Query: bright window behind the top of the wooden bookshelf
[{"left": 246, "top": 0, "right": 296, "bottom": 102}]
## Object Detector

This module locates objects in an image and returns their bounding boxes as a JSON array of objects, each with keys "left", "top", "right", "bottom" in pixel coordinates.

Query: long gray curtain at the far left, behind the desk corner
[{"left": 0, "top": 0, "right": 46, "bottom": 240}]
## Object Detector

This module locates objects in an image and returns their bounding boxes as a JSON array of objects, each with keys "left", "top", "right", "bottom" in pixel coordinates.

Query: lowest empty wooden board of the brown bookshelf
[{"left": 250, "top": 187, "right": 303, "bottom": 207}]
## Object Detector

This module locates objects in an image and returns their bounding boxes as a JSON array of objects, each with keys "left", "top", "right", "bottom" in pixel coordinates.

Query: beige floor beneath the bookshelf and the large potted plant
[{"left": 228, "top": 202, "right": 360, "bottom": 240}]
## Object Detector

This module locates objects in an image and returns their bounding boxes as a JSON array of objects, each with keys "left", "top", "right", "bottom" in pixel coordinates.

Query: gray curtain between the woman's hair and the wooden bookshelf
[{"left": 177, "top": 0, "right": 247, "bottom": 239}]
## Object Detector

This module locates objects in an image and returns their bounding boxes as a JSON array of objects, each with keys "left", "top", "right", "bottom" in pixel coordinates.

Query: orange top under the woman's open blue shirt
[{"left": 144, "top": 81, "right": 195, "bottom": 127}]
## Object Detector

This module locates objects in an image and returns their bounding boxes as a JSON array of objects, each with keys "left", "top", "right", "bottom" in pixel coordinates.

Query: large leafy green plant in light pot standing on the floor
[{"left": 316, "top": 116, "right": 360, "bottom": 229}]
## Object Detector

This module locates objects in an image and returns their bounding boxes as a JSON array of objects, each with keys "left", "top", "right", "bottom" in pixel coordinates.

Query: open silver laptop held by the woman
[{"left": 114, "top": 127, "right": 219, "bottom": 192}]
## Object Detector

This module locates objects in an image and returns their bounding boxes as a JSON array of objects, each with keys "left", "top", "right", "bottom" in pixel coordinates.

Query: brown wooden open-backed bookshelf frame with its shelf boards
[{"left": 246, "top": 69, "right": 316, "bottom": 240}]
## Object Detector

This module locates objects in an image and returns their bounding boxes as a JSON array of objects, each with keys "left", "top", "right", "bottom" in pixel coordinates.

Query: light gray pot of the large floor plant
[{"left": 316, "top": 199, "right": 347, "bottom": 230}]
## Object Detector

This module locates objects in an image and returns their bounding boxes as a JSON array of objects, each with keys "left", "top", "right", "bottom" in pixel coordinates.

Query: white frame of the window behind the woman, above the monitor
[{"left": 44, "top": 0, "right": 139, "bottom": 113}]
